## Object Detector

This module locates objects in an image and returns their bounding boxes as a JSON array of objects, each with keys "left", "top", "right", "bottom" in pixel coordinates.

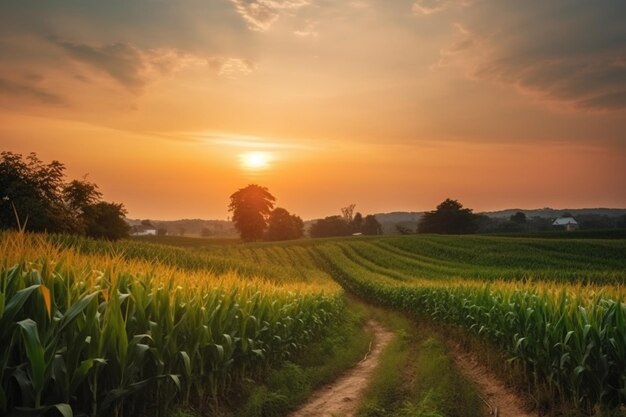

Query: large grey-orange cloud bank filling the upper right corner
[{"left": 437, "top": 0, "right": 626, "bottom": 110}]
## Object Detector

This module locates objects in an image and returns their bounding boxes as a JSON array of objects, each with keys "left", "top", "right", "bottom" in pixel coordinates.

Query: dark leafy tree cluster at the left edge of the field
[{"left": 0, "top": 152, "right": 130, "bottom": 240}]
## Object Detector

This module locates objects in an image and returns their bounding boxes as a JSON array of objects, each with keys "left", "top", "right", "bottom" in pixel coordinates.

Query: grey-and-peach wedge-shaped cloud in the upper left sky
[{"left": 50, "top": 37, "right": 206, "bottom": 93}]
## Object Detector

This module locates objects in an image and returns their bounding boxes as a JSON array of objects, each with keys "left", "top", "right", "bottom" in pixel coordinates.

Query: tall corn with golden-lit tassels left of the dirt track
[{"left": 0, "top": 233, "right": 343, "bottom": 417}]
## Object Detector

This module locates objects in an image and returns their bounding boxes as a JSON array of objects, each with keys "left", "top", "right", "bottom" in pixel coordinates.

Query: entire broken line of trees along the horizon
[{"left": 6, "top": 152, "right": 626, "bottom": 241}]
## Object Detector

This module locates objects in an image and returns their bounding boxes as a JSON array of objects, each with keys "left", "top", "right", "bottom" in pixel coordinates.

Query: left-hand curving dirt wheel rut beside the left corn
[{"left": 289, "top": 320, "right": 393, "bottom": 417}]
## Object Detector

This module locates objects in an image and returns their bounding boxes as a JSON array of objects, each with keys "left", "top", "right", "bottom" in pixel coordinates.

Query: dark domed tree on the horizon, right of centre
[{"left": 418, "top": 198, "right": 477, "bottom": 234}]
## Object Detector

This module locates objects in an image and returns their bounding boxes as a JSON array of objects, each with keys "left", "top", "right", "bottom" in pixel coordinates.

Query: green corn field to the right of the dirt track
[{"left": 316, "top": 237, "right": 626, "bottom": 412}]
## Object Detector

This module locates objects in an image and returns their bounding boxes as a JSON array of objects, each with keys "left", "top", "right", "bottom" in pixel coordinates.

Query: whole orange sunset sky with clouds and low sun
[{"left": 0, "top": 0, "right": 626, "bottom": 219}]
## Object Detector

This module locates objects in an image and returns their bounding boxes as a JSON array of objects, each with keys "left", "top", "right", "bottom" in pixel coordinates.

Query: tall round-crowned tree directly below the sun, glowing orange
[{"left": 228, "top": 184, "right": 276, "bottom": 241}]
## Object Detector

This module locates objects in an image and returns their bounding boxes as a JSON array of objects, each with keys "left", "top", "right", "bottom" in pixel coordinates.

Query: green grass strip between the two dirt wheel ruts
[{"left": 357, "top": 307, "right": 485, "bottom": 417}]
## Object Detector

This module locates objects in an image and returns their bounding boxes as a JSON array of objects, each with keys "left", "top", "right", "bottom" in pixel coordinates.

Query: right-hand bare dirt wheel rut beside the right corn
[{"left": 448, "top": 343, "right": 537, "bottom": 417}]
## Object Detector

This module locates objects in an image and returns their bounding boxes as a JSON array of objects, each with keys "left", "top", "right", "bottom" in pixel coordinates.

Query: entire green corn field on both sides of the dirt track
[{"left": 0, "top": 233, "right": 626, "bottom": 416}]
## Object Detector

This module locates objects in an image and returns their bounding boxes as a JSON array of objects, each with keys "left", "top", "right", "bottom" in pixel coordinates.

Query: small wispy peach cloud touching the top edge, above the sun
[{"left": 230, "top": 0, "right": 309, "bottom": 32}]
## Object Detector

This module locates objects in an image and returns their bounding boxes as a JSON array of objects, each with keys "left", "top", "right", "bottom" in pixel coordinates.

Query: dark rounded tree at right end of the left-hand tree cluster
[{"left": 85, "top": 201, "right": 130, "bottom": 240}]
